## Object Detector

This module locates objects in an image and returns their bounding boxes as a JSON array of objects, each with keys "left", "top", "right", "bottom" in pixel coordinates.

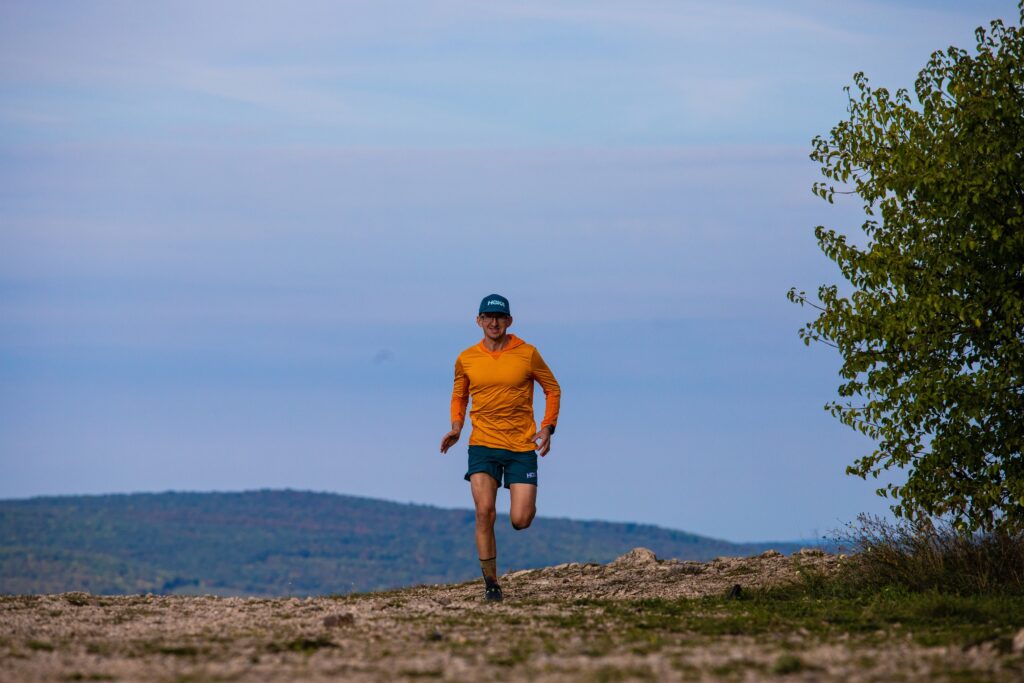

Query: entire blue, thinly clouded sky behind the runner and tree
[{"left": 0, "top": 0, "right": 1018, "bottom": 541}]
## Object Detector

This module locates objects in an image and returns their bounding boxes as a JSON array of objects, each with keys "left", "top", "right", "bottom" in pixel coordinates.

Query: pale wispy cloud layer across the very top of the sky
[{"left": 0, "top": 1, "right": 1005, "bottom": 147}]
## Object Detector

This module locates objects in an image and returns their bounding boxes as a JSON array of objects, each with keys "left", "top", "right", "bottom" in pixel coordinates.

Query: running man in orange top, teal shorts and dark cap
[{"left": 441, "top": 294, "right": 561, "bottom": 601}]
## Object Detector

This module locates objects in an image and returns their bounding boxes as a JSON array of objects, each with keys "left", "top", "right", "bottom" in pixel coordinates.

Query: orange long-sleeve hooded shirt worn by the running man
[{"left": 452, "top": 335, "right": 562, "bottom": 453}]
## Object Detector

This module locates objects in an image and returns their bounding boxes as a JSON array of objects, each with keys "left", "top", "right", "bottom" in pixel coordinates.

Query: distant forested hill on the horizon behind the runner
[{"left": 0, "top": 490, "right": 798, "bottom": 596}]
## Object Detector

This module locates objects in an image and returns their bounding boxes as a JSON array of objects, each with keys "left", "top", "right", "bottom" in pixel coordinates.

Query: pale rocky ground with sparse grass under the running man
[{"left": 0, "top": 548, "right": 1024, "bottom": 683}]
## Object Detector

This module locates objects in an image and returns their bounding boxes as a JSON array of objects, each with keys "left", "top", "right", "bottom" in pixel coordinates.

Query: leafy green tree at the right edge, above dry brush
[{"left": 787, "top": 6, "right": 1024, "bottom": 532}]
